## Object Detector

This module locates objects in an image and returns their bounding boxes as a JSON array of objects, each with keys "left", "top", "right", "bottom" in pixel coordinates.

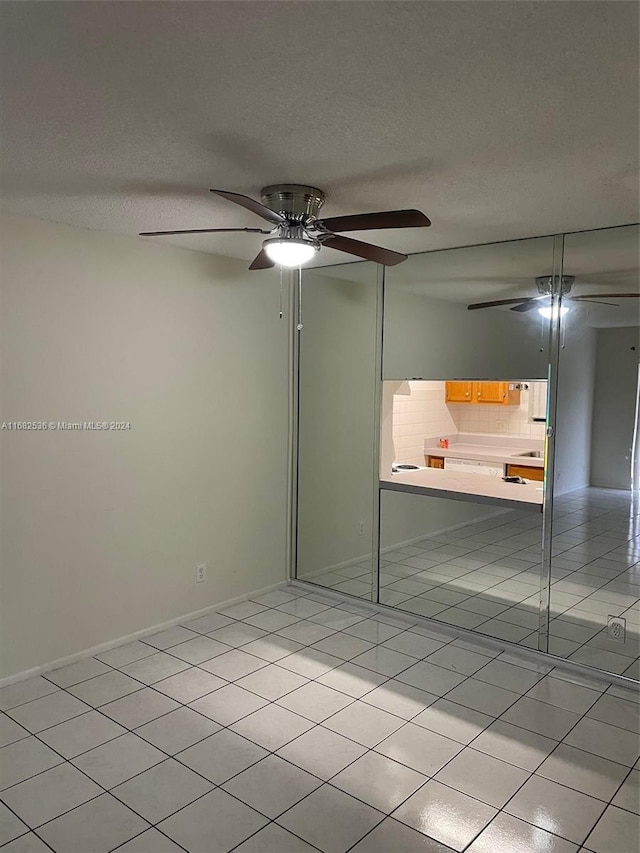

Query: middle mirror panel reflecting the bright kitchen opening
[{"left": 380, "top": 237, "right": 554, "bottom": 648}]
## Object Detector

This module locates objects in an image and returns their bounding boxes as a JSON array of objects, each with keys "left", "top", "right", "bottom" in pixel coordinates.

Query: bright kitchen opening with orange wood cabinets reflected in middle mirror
[{"left": 380, "top": 379, "right": 547, "bottom": 504}]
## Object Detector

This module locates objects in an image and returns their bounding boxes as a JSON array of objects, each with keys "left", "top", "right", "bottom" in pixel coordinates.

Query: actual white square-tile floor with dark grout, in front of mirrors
[{"left": 0, "top": 586, "right": 640, "bottom": 853}]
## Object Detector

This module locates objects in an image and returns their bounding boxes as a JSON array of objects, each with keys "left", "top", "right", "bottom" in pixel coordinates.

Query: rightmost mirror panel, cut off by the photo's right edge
[{"left": 549, "top": 226, "right": 640, "bottom": 680}]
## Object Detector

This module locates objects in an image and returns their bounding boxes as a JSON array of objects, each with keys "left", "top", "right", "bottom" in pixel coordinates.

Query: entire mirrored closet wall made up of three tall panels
[{"left": 297, "top": 226, "right": 640, "bottom": 680}]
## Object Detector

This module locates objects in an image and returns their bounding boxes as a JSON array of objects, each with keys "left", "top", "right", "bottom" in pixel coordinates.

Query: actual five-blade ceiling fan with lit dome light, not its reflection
[{"left": 140, "top": 184, "right": 431, "bottom": 270}]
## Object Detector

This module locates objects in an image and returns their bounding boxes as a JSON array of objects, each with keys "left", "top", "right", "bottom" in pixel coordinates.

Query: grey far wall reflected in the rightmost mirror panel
[{"left": 591, "top": 326, "right": 640, "bottom": 489}]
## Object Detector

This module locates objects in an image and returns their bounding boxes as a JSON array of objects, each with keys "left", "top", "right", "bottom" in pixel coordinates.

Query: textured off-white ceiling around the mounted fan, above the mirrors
[{"left": 0, "top": 0, "right": 639, "bottom": 264}]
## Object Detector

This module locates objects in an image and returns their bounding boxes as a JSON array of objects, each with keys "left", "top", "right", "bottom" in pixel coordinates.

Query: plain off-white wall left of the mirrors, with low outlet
[{"left": 0, "top": 218, "right": 287, "bottom": 675}]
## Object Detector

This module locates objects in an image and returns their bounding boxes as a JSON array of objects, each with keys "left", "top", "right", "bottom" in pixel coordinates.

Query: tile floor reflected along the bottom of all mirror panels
[{"left": 305, "top": 488, "right": 640, "bottom": 680}]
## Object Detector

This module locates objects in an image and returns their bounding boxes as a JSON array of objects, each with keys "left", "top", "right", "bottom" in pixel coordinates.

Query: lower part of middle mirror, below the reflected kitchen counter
[{"left": 380, "top": 491, "right": 542, "bottom": 649}]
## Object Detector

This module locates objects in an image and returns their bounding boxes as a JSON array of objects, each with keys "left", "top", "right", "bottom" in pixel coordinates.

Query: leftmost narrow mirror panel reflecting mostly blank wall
[{"left": 296, "top": 263, "right": 378, "bottom": 599}]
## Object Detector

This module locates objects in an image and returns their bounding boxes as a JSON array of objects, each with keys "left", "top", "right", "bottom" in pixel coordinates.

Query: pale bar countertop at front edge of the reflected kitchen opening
[{"left": 380, "top": 466, "right": 543, "bottom": 509}]
